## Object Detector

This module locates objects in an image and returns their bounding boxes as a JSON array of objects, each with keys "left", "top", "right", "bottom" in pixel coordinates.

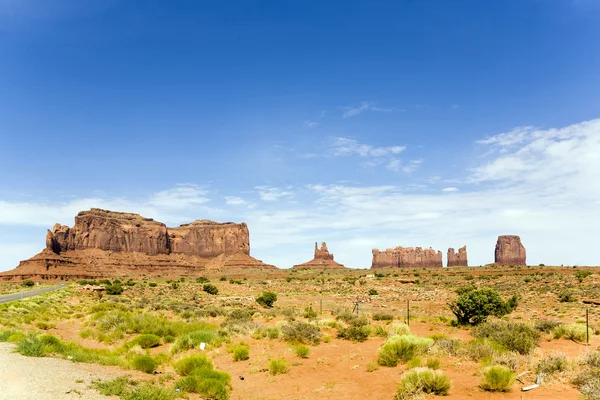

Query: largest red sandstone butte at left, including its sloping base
[{"left": 0, "top": 208, "right": 275, "bottom": 280}]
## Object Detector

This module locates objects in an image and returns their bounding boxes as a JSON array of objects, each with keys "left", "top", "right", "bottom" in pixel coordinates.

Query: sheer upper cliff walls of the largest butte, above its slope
[{"left": 46, "top": 208, "right": 250, "bottom": 257}]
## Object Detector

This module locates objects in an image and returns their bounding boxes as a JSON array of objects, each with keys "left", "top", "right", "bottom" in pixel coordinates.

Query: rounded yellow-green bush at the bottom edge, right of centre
[{"left": 397, "top": 368, "right": 452, "bottom": 400}]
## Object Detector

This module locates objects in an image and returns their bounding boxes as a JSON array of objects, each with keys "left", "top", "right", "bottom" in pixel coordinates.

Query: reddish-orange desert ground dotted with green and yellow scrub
[{"left": 0, "top": 266, "right": 600, "bottom": 400}]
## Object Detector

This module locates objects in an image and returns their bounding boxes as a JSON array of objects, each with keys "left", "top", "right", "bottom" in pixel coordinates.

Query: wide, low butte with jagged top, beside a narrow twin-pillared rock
[{"left": 371, "top": 246, "right": 443, "bottom": 268}]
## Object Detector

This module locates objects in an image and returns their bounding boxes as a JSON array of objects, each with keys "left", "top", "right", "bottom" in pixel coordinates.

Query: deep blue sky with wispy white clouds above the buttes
[{"left": 0, "top": 0, "right": 600, "bottom": 270}]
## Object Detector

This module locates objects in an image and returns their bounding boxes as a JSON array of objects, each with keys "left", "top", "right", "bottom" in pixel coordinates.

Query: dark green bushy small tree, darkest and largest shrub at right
[{"left": 448, "top": 287, "right": 518, "bottom": 325}]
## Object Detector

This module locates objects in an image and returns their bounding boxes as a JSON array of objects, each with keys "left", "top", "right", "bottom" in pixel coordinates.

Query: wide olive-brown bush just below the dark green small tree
[{"left": 473, "top": 321, "right": 540, "bottom": 354}]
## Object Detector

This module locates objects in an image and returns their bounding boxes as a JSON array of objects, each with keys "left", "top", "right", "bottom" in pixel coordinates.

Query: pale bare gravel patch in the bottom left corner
[{"left": 0, "top": 343, "right": 119, "bottom": 400}]
